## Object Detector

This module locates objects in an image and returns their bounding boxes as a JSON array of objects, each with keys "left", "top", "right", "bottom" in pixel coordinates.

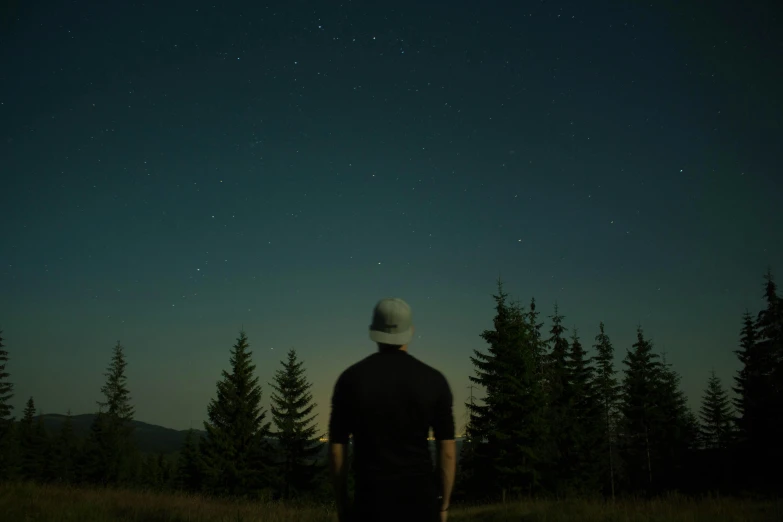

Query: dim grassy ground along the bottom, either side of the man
[{"left": 0, "top": 484, "right": 783, "bottom": 522}]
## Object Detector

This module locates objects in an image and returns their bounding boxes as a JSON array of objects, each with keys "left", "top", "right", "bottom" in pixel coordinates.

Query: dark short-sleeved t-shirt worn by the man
[{"left": 329, "top": 350, "right": 454, "bottom": 488}]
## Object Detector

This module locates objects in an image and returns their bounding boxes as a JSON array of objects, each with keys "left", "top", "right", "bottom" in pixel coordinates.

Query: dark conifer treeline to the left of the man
[{"left": 0, "top": 332, "right": 331, "bottom": 501}]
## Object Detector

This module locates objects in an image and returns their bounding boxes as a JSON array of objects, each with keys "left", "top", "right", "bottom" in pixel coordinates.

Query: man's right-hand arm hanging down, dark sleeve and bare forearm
[{"left": 432, "top": 375, "right": 457, "bottom": 511}]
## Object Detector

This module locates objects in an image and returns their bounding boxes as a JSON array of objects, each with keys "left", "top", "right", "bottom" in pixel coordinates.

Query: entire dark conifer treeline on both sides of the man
[{"left": 0, "top": 272, "right": 783, "bottom": 502}]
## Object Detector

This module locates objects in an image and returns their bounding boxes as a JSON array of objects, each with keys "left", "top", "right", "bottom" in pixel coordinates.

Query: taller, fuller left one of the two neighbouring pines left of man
[{"left": 200, "top": 331, "right": 271, "bottom": 495}]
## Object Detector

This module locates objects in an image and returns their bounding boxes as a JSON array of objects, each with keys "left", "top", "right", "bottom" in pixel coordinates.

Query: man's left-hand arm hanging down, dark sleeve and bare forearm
[{"left": 329, "top": 372, "right": 352, "bottom": 522}]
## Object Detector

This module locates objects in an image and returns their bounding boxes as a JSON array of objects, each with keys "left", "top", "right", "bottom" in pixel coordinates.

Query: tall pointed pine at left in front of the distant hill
[{"left": 84, "top": 341, "right": 138, "bottom": 485}]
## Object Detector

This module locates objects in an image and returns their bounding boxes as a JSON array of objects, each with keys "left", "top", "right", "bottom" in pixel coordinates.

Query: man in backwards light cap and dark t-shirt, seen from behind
[{"left": 329, "top": 299, "right": 456, "bottom": 522}]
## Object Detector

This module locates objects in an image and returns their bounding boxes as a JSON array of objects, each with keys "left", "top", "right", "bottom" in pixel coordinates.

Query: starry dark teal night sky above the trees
[{"left": 0, "top": 0, "right": 783, "bottom": 432}]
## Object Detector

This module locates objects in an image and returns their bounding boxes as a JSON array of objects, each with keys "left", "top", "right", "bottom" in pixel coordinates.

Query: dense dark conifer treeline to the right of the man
[{"left": 456, "top": 272, "right": 783, "bottom": 501}]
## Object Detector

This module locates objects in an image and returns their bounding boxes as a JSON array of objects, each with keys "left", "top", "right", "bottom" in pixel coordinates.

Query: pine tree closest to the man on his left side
[{"left": 269, "top": 349, "right": 323, "bottom": 499}]
